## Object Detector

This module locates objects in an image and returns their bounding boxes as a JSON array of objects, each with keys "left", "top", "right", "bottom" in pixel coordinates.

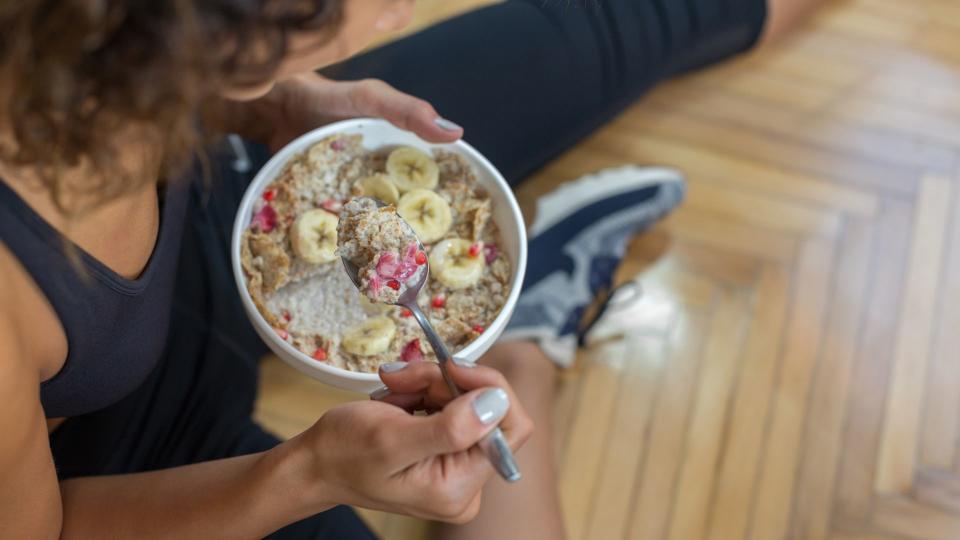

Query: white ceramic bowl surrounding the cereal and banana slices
[{"left": 230, "top": 119, "right": 527, "bottom": 393}]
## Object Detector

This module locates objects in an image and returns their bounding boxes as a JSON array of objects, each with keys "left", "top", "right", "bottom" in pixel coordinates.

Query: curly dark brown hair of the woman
[{"left": 0, "top": 0, "right": 344, "bottom": 213}]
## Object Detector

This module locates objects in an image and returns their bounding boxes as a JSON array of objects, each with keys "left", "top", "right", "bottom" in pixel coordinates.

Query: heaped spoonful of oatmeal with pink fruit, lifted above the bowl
[{"left": 337, "top": 197, "right": 427, "bottom": 304}]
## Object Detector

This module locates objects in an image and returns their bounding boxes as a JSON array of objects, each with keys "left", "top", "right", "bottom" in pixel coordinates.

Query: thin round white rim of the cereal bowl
[{"left": 230, "top": 118, "right": 527, "bottom": 383}]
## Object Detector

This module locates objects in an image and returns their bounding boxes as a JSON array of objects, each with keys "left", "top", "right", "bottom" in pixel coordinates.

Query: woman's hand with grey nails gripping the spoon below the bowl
[{"left": 291, "top": 362, "right": 533, "bottom": 523}]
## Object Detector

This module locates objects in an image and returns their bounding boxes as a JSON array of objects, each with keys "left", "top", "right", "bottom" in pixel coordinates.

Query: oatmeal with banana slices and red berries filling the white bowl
[{"left": 241, "top": 135, "right": 512, "bottom": 372}]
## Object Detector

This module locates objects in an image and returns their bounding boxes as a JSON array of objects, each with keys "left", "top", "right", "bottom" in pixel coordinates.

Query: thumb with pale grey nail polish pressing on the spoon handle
[{"left": 394, "top": 387, "right": 510, "bottom": 461}]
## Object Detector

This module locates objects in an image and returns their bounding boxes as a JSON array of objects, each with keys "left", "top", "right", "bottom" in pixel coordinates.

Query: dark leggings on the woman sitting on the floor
[{"left": 51, "top": 0, "right": 766, "bottom": 539}]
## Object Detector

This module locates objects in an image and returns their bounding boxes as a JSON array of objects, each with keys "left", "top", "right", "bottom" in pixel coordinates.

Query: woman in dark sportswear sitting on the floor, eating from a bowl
[{"left": 0, "top": 0, "right": 814, "bottom": 538}]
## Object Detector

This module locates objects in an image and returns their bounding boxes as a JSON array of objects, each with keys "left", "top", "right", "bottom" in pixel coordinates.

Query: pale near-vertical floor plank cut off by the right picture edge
[{"left": 920, "top": 181, "right": 960, "bottom": 469}]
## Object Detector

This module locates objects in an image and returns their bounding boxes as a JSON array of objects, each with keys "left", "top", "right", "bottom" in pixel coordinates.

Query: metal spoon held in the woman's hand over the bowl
[{"left": 340, "top": 199, "right": 521, "bottom": 483}]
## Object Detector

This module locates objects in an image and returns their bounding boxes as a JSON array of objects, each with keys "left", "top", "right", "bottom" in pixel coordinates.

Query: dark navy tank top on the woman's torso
[{"left": 0, "top": 180, "right": 188, "bottom": 418}]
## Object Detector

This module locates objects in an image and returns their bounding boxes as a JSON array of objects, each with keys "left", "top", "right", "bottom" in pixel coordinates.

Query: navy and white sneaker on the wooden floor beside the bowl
[{"left": 502, "top": 166, "right": 686, "bottom": 367}]
